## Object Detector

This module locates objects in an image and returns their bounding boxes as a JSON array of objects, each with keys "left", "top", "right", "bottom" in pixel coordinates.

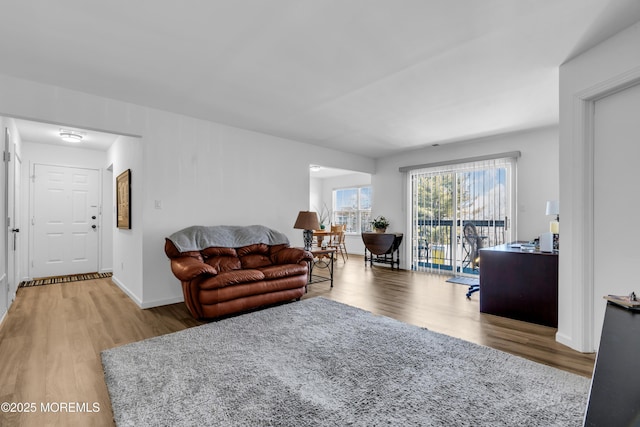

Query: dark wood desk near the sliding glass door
[{"left": 480, "top": 245, "right": 558, "bottom": 328}]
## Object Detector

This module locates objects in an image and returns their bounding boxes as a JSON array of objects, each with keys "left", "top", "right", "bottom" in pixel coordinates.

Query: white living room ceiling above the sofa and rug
[{"left": 0, "top": 0, "right": 640, "bottom": 158}]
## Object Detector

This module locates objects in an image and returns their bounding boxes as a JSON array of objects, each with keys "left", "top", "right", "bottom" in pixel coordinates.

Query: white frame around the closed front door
[{"left": 27, "top": 161, "right": 104, "bottom": 279}]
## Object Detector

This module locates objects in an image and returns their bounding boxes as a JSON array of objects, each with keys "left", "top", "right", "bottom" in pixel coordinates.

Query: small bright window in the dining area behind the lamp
[{"left": 333, "top": 186, "right": 371, "bottom": 233}]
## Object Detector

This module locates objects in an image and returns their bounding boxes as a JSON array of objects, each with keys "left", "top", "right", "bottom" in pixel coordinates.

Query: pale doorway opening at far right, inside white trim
[{"left": 590, "top": 84, "right": 640, "bottom": 349}]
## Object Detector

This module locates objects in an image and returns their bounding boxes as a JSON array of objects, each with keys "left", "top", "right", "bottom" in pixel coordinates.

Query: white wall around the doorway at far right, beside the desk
[{"left": 556, "top": 22, "right": 640, "bottom": 352}]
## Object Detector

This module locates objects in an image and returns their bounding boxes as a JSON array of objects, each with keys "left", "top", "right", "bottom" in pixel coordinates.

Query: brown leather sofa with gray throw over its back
[{"left": 165, "top": 226, "right": 312, "bottom": 319}]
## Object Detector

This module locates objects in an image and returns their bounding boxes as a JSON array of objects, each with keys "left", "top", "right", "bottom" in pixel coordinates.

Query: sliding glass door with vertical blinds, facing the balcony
[{"left": 408, "top": 157, "right": 515, "bottom": 274}]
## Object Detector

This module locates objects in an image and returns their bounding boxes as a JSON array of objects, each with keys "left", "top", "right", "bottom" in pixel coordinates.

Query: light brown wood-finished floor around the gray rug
[{"left": 0, "top": 256, "right": 595, "bottom": 426}]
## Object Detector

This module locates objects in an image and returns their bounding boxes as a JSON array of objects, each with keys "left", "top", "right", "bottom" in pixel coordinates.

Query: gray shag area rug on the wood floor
[{"left": 102, "top": 297, "right": 589, "bottom": 427}]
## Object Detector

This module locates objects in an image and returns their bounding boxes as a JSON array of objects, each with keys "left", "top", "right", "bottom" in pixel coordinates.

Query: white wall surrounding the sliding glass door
[{"left": 372, "top": 127, "right": 559, "bottom": 268}]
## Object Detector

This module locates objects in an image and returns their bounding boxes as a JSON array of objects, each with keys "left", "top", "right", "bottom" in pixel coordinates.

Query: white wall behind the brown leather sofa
[{"left": 0, "top": 75, "right": 375, "bottom": 307}]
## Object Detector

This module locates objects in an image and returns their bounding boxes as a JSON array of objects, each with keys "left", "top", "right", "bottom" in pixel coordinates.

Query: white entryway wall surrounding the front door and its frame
[{"left": 20, "top": 141, "right": 113, "bottom": 279}]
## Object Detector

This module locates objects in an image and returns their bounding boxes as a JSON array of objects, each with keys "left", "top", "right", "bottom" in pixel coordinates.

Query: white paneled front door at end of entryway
[{"left": 30, "top": 164, "right": 100, "bottom": 278}]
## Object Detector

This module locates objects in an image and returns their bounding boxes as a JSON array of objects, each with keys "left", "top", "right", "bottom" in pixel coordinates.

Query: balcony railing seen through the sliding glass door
[{"left": 412, "top": 219, "right": 506, "bottom": 274}]
